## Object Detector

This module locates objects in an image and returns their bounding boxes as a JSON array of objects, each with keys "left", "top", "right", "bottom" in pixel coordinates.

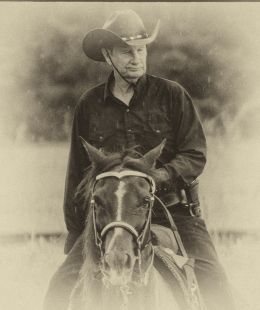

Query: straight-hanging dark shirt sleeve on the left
[{"left": 63, "top": 104, "right": 90, "bottom": 234}]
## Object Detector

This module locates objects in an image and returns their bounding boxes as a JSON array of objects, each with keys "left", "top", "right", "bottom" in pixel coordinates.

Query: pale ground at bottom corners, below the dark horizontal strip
[{"left": 0, "top": 237, "right": 260, "bottom": 310}]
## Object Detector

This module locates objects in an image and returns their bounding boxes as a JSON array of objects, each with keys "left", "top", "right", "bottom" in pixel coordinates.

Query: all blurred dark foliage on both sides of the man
[{"left": 16, "top": 6, "right": 250, "bottom": 141}]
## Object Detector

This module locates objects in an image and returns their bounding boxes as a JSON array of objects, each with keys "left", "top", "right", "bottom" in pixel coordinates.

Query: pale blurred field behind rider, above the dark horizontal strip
[{"left": 0, "top": 135, "right": 260, "bottom": 234}]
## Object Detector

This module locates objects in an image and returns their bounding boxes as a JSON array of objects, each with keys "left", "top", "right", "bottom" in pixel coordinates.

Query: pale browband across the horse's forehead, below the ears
[{"left": 96, "top": 170, "right": 156, "bottom": 194}]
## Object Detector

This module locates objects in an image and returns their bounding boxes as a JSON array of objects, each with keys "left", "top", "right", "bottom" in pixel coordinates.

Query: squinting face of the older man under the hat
[{"left": 107, "top": 45, "right": 147, "bottom": 82}]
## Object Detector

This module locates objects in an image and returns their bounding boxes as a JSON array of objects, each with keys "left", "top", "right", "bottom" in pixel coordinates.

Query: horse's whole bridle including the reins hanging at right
[{"left": 88, "top": 170, "right": 204, "bottom": 309}]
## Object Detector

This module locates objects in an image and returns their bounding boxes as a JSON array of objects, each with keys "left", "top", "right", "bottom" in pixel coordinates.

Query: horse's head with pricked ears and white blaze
[{"left": 80, "top": 141, "right": 164, "bottom": 286}]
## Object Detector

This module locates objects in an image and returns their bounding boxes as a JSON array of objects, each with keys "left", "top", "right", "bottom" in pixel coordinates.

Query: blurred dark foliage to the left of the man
[{"left": 20, "top": 24, "right": 108, "bottom": 141}]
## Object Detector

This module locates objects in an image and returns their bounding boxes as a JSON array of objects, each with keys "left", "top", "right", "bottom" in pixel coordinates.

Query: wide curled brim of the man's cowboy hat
[{"left": 82, "top": 21, "right": 160, "bottom": 61}]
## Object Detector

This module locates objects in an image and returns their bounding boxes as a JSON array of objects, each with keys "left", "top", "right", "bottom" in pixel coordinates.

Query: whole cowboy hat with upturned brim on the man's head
[{"left": 83, "top": 10, "right": 159, "bottom": 61}]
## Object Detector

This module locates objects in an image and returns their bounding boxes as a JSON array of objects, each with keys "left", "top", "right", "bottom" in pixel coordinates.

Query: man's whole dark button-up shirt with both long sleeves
[{"left": 64, "top": 74, "right": 206, "bottom": 253}]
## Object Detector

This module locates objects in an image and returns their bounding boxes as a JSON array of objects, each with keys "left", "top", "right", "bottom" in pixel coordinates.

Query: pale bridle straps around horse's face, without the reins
[{"left": 90, "top": 170, "right": 156, "bottom": 284}]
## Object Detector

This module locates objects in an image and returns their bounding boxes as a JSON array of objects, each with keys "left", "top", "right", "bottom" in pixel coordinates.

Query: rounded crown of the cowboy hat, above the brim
[{"left": 103, "top": 10, "right": 148, "bottom": 39}]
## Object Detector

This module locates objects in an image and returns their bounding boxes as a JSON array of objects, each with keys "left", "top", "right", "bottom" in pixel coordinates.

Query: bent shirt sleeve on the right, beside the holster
[{"left": 164, "top": 88, "right": 206, "bottom": 184}]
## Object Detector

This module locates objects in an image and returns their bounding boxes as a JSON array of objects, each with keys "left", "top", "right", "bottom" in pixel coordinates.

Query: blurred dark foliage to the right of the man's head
[{"left": 150, "top": 16, "right": 245, "bottom": 130}]
